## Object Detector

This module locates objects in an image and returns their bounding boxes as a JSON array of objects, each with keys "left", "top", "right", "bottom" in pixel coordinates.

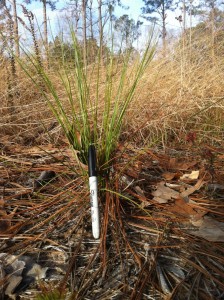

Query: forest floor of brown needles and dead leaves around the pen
[{"left": 0, "top": 136, "right": 224, "bottom": 300}]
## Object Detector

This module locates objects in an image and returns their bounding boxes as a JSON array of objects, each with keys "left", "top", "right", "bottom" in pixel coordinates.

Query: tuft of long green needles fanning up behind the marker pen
[{"left": 19, "top": 27, "right": 156, "bottom": 175}]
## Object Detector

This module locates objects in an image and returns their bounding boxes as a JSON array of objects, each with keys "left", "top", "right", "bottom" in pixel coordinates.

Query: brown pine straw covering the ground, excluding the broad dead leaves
[{"left": 1, "top": 141, "right": 224, "bottom": 300}]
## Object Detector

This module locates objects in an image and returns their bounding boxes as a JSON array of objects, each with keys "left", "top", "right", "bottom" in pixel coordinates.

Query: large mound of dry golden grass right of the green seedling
[{"left": 126, "top": 35, "right": 224, "bottom": 144}]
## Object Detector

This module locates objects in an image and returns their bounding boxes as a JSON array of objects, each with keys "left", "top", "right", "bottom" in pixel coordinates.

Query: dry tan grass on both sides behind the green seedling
[{"left": 0, "top": 34, "right": 224, "bottom": 149}]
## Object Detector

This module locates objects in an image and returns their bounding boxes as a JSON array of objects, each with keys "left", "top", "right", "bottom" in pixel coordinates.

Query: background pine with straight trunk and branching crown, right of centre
[{"left": 142, "top": 0, "right": 174, "bottom": 49}]
